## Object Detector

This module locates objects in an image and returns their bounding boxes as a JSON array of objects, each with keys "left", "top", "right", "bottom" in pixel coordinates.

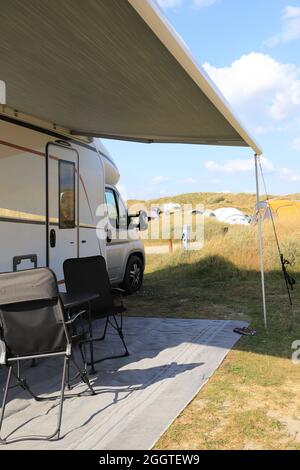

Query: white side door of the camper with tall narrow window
[{"left": 46, "top": 143, "right": 79, "bottom": 282}]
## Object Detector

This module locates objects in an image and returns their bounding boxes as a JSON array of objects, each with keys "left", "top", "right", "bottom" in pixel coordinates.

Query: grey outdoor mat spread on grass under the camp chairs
[{"left": 0, "top": 317, "right": 247, "bottom": 450}]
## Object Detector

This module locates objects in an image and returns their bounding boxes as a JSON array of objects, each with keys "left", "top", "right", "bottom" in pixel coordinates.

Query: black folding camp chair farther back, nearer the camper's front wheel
[{"left": 64, "top": 256, "right": 129, "bottom": 367}]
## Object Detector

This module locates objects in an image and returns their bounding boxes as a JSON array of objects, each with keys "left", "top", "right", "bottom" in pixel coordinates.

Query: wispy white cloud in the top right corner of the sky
[{"left": 266, "top": 6, "right": 300, "bottom": 47}]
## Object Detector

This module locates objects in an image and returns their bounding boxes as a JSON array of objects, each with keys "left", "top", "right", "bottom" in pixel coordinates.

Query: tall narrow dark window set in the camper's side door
[{"left": 59, "top": 160, "right": 76, "bottom": 229}]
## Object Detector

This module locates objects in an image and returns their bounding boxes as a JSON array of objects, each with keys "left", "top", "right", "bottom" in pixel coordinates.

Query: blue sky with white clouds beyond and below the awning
[{"left": 103, "top": 0, "right": 300, "bottom": 199}]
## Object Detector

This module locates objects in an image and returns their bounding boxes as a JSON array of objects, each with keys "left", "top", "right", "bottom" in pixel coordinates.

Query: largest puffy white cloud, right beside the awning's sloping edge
[{"left": 204, "top": 52, "right": 300, "bottom": 133}]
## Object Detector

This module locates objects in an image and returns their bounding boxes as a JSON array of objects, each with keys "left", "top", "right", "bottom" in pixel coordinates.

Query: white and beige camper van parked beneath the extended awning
[{"left": 0, "top": 109, "right": 145, "bottom": 288}]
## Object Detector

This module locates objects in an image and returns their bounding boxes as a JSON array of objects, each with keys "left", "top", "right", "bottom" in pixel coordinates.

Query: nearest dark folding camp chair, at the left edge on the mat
[{"left": 0, "top": 268, "right": 95, "bottom": 444}]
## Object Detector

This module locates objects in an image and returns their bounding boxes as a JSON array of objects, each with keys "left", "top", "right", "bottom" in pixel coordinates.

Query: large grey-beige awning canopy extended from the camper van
[{"left": 0, "top": 0, "right": 261, "bottom": 154}]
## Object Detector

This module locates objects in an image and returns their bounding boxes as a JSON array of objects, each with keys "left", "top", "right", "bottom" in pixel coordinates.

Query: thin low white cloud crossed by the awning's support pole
[{"left": 205, "top": 157, "right": 274, "bottom": 173}]
